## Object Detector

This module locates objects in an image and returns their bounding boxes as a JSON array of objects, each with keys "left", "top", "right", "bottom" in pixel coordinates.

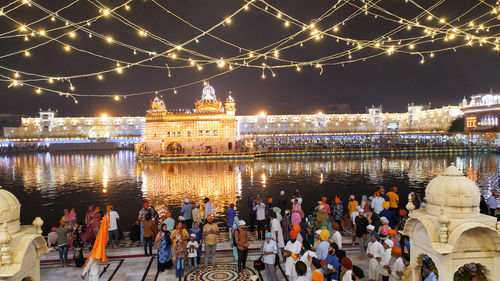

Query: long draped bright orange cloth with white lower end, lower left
[{"left": 81, "top": 216, "right": 108, "bottom": 281}]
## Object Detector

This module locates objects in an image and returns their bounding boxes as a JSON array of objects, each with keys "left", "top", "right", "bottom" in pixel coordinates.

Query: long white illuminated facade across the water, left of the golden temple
[{"left": 3, "top": 110, "right": 144, "bottom": 138}]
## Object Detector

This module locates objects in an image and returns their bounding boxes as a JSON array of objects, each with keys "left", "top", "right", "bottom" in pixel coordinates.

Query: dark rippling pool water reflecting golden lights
[{"left": 0, "top": 151, "right": 500, "bottom": 230}]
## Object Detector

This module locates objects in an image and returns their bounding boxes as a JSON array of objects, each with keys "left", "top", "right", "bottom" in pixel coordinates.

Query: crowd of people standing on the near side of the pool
[{"left": 47, "top": 187, "right": 500, "bottom": 281}]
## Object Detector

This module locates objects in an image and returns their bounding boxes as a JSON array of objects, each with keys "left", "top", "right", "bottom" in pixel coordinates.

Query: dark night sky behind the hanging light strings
[{"left": 0, "top": 0, "right": 500, "bottom": 116}]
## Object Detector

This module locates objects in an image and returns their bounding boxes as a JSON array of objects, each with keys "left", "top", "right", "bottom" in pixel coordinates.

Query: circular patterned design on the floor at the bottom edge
[{"left": 184, "top": 264, "right": 258, "bottom": 281}]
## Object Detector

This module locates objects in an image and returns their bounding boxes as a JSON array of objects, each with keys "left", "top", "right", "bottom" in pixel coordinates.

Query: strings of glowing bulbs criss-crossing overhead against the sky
[{"left": 0, "top": 0, "right": 498, "bottom": 101}]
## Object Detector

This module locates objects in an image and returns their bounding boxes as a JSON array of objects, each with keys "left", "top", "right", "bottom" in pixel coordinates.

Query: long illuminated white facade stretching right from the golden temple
[{"left": 236, "top": 104, "right": 463, "bottom": 137}]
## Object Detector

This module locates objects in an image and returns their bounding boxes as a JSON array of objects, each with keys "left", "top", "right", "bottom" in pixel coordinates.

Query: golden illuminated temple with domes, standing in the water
[{"left": 136, "top": 86, "right": 236, "bottom": 157}]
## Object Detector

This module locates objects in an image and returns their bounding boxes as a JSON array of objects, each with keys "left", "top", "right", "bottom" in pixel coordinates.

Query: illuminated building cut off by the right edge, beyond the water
[{"left": 463, "top": 91, "right": 500, "bottom": 132}]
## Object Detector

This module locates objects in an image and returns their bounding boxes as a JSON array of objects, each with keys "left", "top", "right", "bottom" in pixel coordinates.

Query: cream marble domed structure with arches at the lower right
[{"left": 402, "top": 164, "right": 500, "bottom": 281}]
